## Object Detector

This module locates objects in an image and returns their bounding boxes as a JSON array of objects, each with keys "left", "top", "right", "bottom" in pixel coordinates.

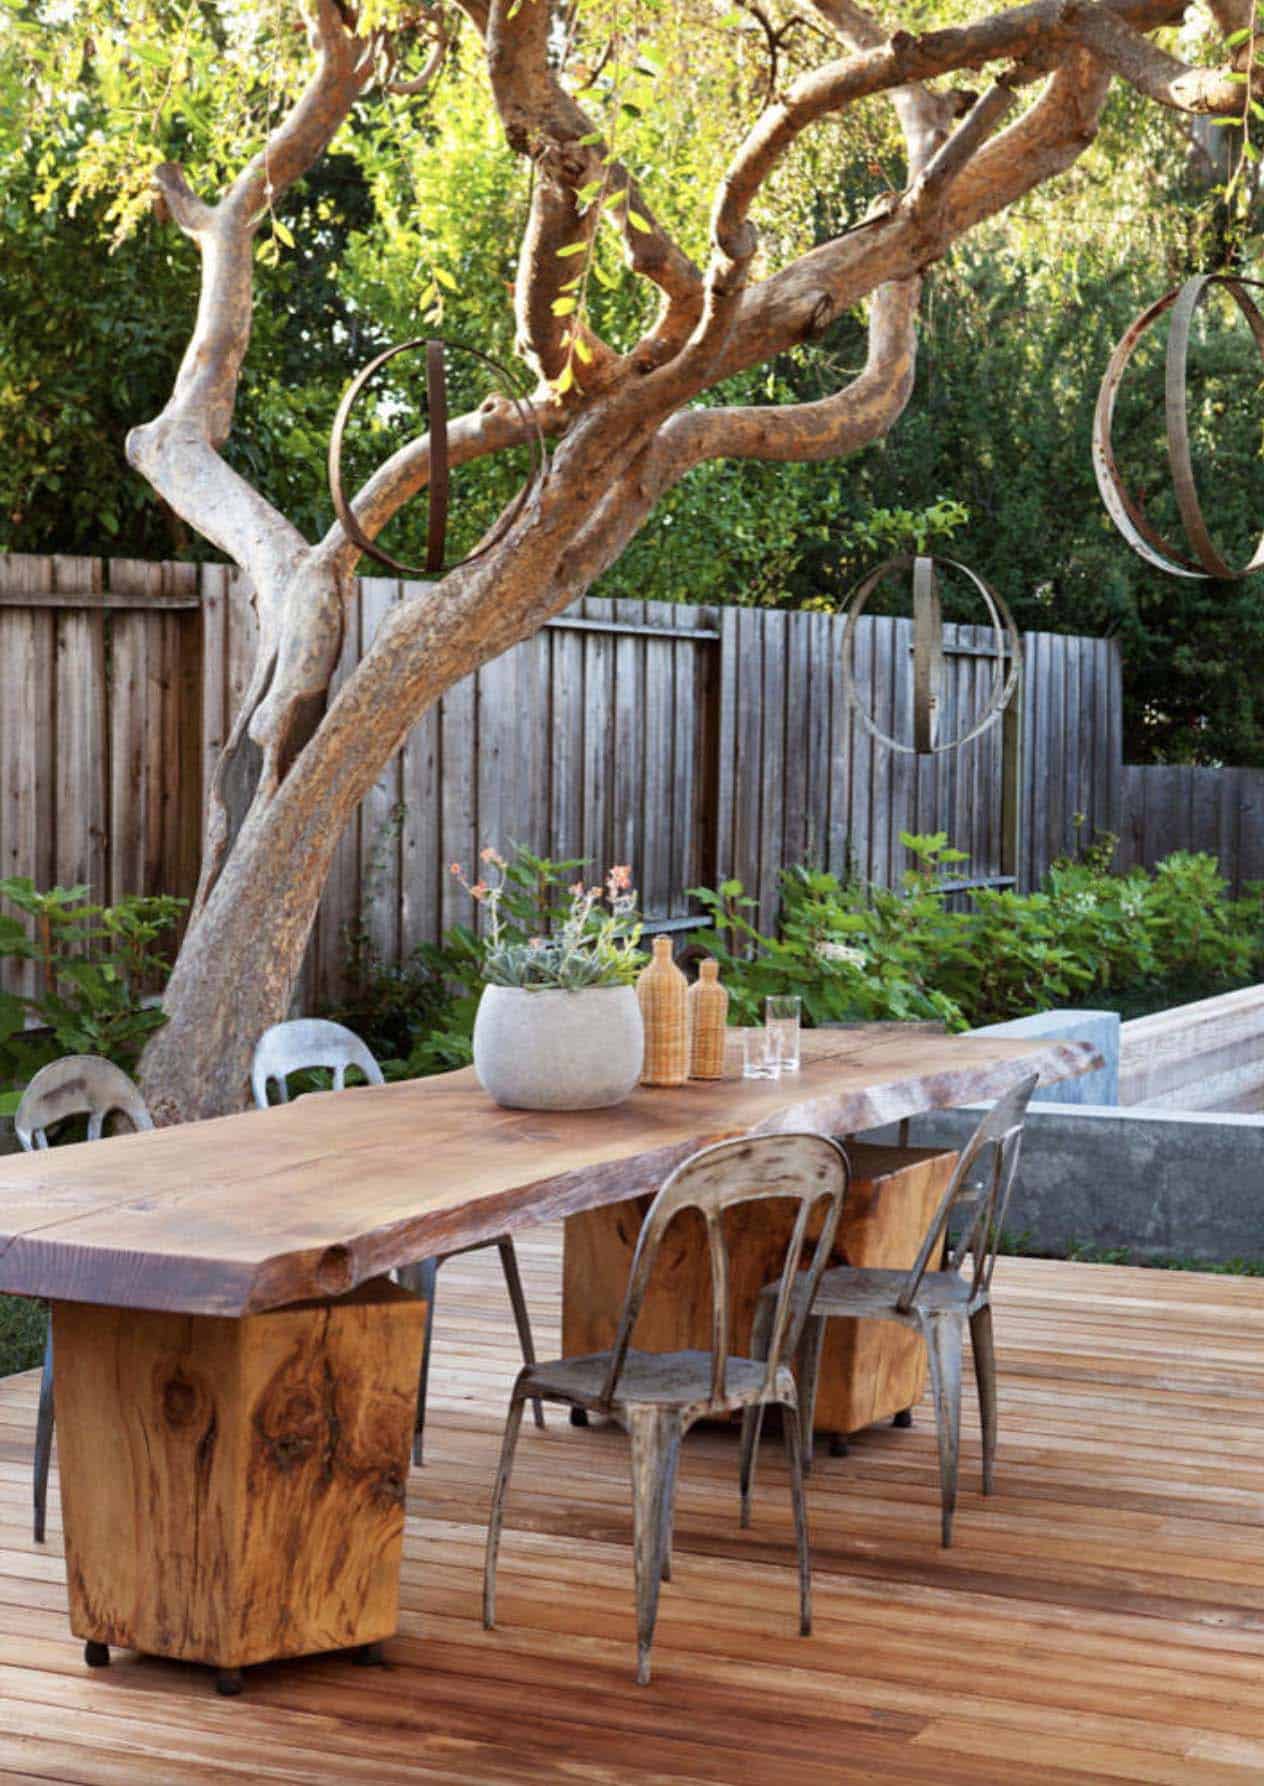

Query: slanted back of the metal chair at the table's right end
[{"left": 896, "top": 1073, "right": 1041, "bottom": 1314}]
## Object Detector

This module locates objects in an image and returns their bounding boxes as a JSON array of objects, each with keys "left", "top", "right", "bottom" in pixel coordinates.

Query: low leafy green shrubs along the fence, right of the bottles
[{"left": 681, "top": 832, "right": 1264, "bottom": 1029}]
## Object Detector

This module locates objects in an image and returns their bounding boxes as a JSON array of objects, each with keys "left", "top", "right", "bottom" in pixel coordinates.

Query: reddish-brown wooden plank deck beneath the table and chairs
[{"left": 0, "top": 1231, "right": 1264, "bottom": 1786}]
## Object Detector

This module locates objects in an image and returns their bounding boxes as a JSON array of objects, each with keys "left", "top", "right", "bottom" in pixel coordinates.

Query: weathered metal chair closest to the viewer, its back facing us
[{"left": 482, "top": 1134, "right": 848, "bottom": 1686}]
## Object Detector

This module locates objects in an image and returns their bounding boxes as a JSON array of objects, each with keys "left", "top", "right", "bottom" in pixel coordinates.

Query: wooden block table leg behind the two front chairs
[{"left": 562, "top": 1145, "right": 957, "bottom": 1434}]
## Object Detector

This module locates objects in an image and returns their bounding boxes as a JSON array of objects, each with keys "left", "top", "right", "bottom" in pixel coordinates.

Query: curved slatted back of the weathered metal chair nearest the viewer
[{"left": 602, "top": 1132, "right": 850, "bottom": 1404}]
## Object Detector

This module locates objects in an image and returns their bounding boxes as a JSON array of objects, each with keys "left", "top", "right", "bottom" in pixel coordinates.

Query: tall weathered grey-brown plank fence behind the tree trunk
[{"left": 0, "top": 557, "right": 1123, "bottom": 998}]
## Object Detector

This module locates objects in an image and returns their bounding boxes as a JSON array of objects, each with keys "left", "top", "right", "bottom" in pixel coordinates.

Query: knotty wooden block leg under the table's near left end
[{"left": 54, "top": 1279, "right": 425, "bottom": 1679}]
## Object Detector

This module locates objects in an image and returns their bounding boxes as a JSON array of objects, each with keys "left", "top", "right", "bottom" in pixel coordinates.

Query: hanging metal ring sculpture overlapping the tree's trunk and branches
[{"left": 328, "top": 336, "right": 548, "bottom": 577}]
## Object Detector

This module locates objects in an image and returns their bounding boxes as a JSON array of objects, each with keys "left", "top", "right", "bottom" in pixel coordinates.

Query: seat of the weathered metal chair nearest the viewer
[{"left": 521, "top": 1350, "right": 785, "bottom": 1420}]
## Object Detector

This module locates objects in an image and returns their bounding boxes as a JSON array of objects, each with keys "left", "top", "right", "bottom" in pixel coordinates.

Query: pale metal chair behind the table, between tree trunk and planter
[{"left": 250, "top": 1016, "right": 545, "bottom": 1465}]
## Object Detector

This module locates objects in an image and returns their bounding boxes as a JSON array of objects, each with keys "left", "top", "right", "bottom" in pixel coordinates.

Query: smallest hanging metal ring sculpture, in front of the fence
[{"left": 843, "top": 552, "right": 1023, "bottom": 755}]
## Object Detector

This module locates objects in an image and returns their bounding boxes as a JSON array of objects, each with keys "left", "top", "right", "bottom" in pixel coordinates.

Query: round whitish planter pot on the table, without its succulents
[{"left": 473, "top": 986, "right": 644, "bottom": 1111}]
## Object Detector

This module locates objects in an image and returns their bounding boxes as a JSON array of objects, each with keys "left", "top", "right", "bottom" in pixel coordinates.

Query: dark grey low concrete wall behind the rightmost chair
[{"left": 862, "top": 1104, "right": 1264, "bottom": 1264}]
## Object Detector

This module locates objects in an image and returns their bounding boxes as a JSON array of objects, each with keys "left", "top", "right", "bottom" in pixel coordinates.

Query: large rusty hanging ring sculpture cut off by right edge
[{"left": 1093, "top": 273, "right": 1264, "bottom": 580}]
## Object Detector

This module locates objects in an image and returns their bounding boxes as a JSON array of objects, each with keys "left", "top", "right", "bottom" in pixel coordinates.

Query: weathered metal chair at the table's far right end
[{"left": 741, "top": 1073, "right": 1039, "bottom": 1548}]
